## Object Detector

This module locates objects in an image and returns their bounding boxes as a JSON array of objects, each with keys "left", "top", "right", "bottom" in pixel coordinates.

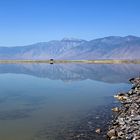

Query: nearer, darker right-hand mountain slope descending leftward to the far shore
[{"left": 59, "top": 36, "right": 140, "bottom": 59}]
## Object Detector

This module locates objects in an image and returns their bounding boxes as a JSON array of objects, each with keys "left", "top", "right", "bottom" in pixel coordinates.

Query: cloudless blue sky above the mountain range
[{"left": 0, "top": 0, "right": 140, "bottom": 46}]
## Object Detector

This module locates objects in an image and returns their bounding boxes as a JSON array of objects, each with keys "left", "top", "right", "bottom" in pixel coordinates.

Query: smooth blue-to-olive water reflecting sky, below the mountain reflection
[{"left": 0, "top": 64, "right": 136, "bottom": 140}]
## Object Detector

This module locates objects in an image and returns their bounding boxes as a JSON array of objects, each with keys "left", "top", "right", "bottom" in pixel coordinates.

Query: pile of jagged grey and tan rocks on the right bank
[{"left": 107, "top": 78, "right": 140, "bottom": 140}]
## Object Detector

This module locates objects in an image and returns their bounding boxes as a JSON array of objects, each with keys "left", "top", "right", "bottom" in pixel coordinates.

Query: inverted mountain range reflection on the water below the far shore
[{"left": 0, "top": 64, "right": 140, "bottom": 83}]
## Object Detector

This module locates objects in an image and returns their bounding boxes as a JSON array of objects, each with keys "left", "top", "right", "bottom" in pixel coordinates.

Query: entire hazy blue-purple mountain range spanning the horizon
[{"left": 0, "top": 36, "right": 140, "bottom": 60}]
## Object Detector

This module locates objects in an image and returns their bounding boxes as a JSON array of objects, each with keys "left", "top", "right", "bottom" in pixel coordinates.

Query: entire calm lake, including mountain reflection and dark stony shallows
[{"left": 0, "top": 64, "right": 140, "bottom": 140}]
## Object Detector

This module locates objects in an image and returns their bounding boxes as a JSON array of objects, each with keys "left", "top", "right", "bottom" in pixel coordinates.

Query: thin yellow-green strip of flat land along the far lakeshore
[{"left": 0, "top": 59, "right": 140, "bottom": 64}]
